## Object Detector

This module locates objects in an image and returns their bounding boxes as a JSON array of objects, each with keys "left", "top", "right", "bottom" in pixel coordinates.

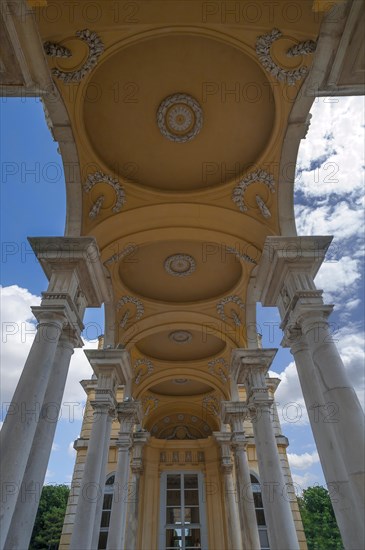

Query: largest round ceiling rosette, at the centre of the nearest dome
[{"left": 157, "top": 94, "right": 203, "bottom": 143}]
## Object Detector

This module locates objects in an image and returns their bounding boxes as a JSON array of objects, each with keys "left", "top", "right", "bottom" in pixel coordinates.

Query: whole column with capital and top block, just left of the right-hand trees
[{"left": 232, "top": 349, "right": 299, "bottom": 550}]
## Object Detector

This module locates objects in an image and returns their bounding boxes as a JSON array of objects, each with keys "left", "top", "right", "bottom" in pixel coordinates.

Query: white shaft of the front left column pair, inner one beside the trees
[{"left": 5, "top": 331, "right": 79, "bottom": 550}]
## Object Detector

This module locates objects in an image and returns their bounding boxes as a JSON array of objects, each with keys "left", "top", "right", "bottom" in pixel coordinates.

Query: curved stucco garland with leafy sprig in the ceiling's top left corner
[{"left": 43, "top": 29, "right": 104, "bottom": 84}]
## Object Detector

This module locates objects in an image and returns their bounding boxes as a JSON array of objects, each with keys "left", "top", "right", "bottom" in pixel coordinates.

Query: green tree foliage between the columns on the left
[{"left": 29, "top": 485, "right": 70, "bottom": 550}]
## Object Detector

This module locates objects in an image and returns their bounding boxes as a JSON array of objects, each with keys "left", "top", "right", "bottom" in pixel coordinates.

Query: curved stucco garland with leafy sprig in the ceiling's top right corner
[{"left": 256, "top": 29, "right": 314, "bottom": 86}]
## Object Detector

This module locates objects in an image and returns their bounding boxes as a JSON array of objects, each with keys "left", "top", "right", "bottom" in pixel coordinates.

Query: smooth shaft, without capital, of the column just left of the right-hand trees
[{"left": 252, "top": 404, "right": 299, "bottom": 550}]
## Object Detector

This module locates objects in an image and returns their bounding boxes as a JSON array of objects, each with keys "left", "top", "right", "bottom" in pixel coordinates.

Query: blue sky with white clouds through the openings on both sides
[{"left": 0, "top": 97, "right": 365, "bottom": 492}]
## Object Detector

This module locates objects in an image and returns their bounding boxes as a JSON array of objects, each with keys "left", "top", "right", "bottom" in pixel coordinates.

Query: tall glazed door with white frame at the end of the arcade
[{"left": 159, "top": 472, "right": 208, "bottom": 550}]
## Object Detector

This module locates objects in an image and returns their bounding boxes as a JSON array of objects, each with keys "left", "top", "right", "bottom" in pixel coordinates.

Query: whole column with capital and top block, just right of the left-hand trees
[{"left": 70, "top": 349, "right": 131, "bottom": 550}]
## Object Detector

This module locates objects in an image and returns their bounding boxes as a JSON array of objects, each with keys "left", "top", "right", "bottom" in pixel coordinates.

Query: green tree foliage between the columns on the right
[{"left": 298, "top": 487, "right": 343, "bottom": 550}]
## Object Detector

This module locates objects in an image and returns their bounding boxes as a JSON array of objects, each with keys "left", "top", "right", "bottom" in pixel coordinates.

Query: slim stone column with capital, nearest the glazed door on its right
[{"left": 213, "top": 432, "right": 243, "bottom": 550}]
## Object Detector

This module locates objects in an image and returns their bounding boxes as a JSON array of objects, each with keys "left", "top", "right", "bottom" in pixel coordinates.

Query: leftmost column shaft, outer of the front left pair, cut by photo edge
[{"left": 0, "top": 315, "right": 63, "bottom": 548}]
